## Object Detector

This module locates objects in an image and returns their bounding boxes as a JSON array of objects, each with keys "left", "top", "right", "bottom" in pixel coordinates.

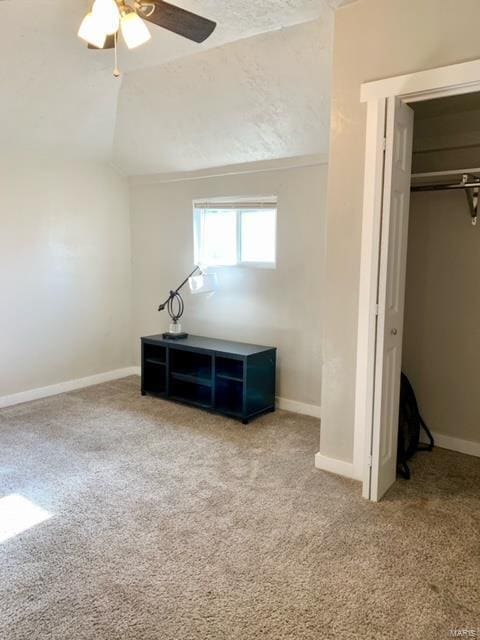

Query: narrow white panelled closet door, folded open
[{"left": 370, "top": 98, "right": 413, "bottom": 500}]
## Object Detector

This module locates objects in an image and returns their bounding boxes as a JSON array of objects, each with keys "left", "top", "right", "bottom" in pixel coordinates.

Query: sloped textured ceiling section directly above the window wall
[{"left": 114, "top": 21, "right": 331, "bottom": 175}]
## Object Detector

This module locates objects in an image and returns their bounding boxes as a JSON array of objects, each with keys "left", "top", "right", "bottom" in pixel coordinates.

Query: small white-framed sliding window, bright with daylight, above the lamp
[{"left": 193, "top": 198, "right": 277, "bottom": 268}]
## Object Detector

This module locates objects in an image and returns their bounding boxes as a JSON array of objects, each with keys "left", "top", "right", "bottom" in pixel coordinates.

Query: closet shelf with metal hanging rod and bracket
[{"left": 411, "top": 169, "right": 480, "bottom": 226}]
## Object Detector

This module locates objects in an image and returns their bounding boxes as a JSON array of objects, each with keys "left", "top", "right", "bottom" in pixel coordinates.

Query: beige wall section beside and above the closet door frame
[{"left": 320, "top": 0, "right": 480, "bottom": 462}]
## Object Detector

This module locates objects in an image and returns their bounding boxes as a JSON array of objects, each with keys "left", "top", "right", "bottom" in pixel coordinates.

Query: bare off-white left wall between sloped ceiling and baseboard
[{"left": 0, "top": 163, "right": 132, "bottom": 396}]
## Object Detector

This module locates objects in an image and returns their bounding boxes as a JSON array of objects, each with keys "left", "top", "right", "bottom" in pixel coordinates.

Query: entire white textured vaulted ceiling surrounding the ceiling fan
[{"left": 0, "top": 0, "right": 343, "bottom": 174}]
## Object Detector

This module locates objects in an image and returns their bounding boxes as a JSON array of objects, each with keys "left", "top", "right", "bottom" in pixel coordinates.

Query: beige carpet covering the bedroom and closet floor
[{"left": 0, "top": 377, "right": 480, "bottom": 640}]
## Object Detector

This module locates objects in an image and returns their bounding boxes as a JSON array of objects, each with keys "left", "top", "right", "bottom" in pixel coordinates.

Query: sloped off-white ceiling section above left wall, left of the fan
[{"left": 0, "top": 0, "right": 120, "bottom": 158}]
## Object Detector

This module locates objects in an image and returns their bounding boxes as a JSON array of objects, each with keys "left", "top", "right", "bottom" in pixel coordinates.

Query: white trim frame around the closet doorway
[{"left": 353, "top": 60, "right": 480, "bottom": 500}]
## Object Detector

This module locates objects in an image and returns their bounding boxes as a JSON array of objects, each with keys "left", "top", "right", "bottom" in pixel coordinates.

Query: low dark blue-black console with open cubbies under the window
[{"left": 141, "top": 335, "right": 276, "bottom": 424}]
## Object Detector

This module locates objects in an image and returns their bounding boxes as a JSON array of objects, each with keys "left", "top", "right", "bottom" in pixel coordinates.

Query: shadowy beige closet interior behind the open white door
[{"left": 402, "top": 94, "right": 480, "bottom": 456}]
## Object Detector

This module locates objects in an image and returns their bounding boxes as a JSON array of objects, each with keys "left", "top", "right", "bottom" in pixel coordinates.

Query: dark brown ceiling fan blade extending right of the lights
[{"left": 137, "top": 0, "right": 217, "bottom": 42}]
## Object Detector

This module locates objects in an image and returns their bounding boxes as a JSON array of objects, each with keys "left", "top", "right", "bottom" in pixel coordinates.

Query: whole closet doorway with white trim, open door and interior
[{"left": 354, "top": 61, "right": 480, "bottom": 500}]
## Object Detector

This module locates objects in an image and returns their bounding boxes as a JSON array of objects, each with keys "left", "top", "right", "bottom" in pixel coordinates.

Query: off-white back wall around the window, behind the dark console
[{"left": 131, "top": 165, "right": 327, "bottom": 405}]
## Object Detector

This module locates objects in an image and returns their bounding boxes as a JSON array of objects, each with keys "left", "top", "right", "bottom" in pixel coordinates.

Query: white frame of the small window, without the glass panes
[{"left": 193, "top": 197, "right": 278, "bottom": 269}]
